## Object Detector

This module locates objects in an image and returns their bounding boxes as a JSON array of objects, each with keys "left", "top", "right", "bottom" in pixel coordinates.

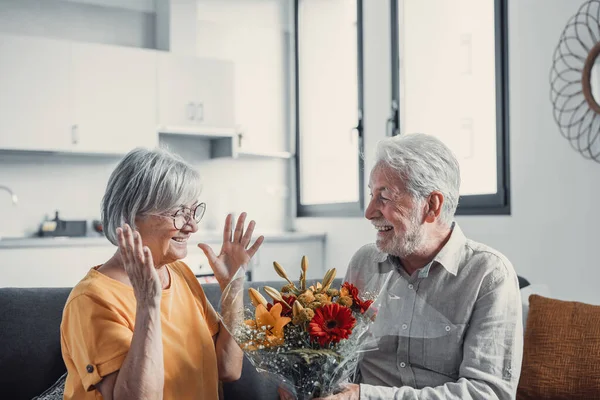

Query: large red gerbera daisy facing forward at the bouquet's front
[{"left": 308, "top": 303, "right": 356, "bottom": 346}]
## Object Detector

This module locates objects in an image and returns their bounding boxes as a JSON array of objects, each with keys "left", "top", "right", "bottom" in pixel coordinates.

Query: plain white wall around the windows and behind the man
[{"left": 296, "top": 0, "right": 600, "bottom": 304}]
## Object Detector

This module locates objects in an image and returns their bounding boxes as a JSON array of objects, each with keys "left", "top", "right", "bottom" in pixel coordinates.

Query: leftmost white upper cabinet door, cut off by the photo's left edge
[{"left": 0, "top": 35, "right": 72, "bottom": 151}]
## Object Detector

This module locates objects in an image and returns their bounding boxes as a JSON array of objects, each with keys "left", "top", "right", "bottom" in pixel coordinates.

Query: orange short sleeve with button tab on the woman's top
[{"left": 61, "top": 295, "right": 133, "bottom": 391}]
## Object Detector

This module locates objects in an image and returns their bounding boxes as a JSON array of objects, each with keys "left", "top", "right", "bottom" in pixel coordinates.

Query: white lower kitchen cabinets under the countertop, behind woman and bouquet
[{"left": 0, "top": 233, "right": 326, "bottom": 287}]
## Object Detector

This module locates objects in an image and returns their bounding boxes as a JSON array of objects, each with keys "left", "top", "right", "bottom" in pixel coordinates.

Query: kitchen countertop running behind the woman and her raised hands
[{"left": 0, "top": 231, "right": 325, "bottom": 250}]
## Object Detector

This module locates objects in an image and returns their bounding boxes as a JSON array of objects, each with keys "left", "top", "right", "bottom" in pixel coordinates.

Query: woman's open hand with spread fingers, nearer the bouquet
[{"left": 198, "top": 212, "right": 265, "bottom": 288}]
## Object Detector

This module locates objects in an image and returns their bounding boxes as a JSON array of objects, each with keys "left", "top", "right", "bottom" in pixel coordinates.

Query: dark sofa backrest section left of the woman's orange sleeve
[{"left": 0, "top": 288, "right": 71, "bottom": 400}]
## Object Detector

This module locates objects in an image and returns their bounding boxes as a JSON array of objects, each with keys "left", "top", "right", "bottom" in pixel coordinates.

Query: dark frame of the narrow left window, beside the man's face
[{"left": 294, "top": 0, "right": 365, "bottom": 217}]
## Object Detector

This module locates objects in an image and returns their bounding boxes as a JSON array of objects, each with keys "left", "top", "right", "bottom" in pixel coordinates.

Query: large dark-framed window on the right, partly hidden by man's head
[{"left": 392, "top": 0, "right": 510, "bottom": 214}]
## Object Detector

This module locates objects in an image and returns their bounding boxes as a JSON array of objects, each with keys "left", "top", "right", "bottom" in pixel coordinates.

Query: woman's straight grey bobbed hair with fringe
[{"left": 102, "top": 148, "right": 202, "bottom": 246}]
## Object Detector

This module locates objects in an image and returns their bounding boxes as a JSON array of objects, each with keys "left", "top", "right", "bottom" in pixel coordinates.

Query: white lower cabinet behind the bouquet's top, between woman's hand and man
[{"left": 252, "top": 238, "right": 326, "bottom": 281}]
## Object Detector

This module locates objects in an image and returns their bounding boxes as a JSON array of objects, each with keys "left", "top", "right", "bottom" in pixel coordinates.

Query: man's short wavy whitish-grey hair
[{"left": 375, "top": 133, "right": 460, "bottom": 225}]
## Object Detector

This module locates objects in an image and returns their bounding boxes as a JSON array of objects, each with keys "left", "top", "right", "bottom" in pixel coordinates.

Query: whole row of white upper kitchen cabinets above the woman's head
[{"left": 0, "top": 34, "right": 237, "bottom": 158}]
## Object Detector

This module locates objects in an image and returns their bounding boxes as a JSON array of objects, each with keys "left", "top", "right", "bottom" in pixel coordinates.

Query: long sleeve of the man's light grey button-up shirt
[{"left": 360, "top": 269, "right": 523, "bottom": 400}]
